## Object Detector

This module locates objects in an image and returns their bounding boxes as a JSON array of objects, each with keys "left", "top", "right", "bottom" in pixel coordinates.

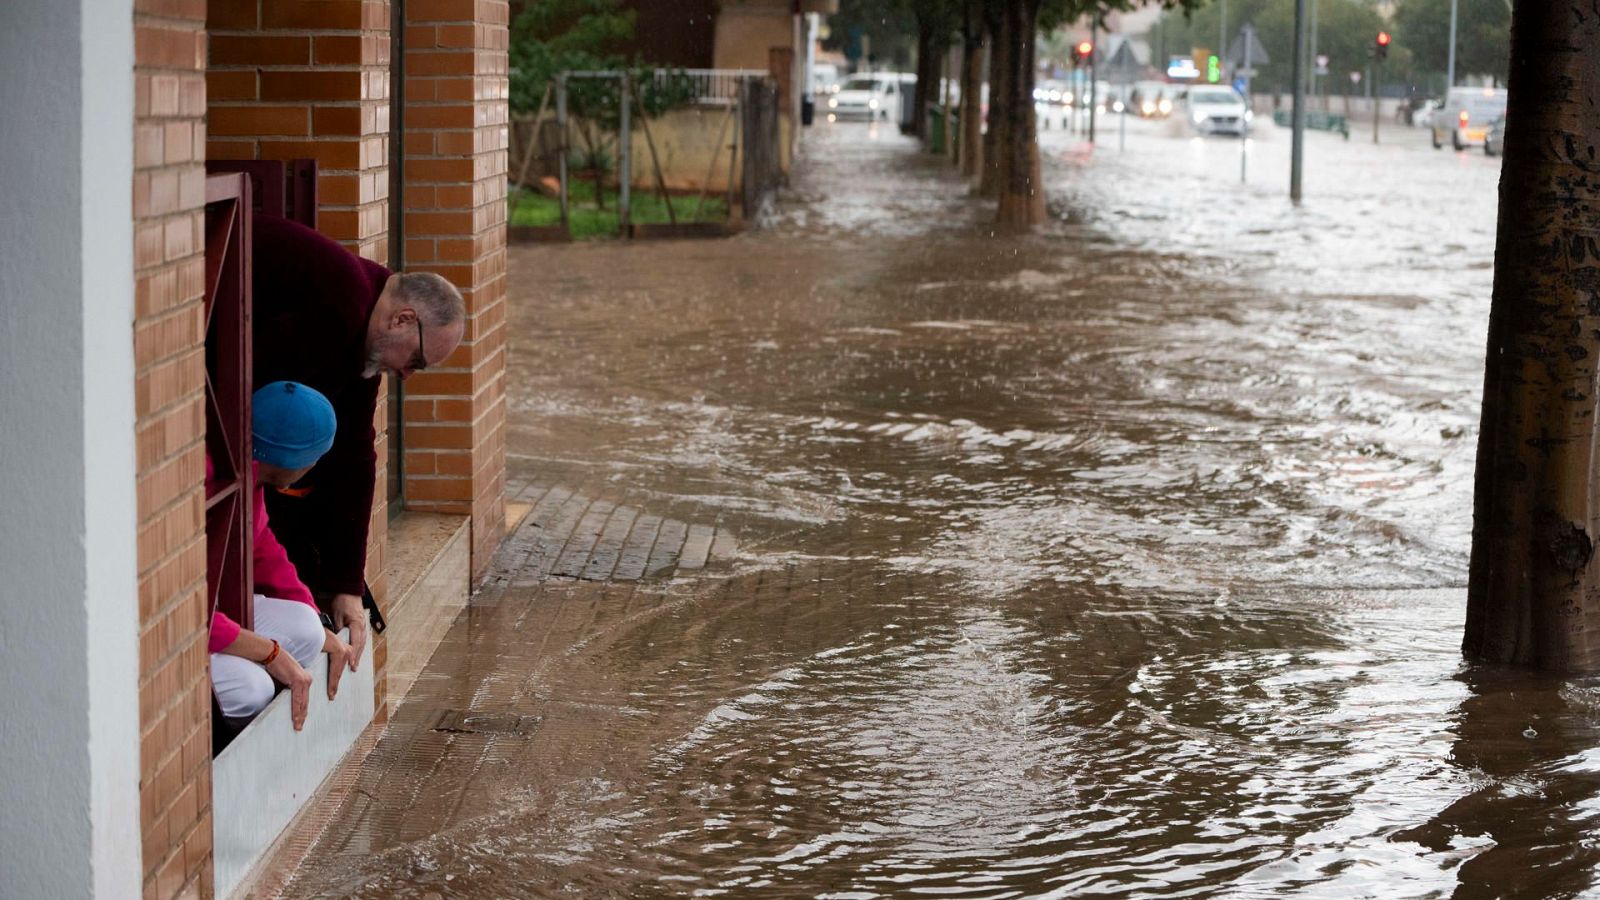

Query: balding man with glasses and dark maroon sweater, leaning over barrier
[{"left": 251, "top": 215, "right": 466, "bottom": 669}]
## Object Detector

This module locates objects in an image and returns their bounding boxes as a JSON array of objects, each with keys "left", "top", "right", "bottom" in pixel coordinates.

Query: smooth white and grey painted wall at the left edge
[{"left": 0, "top": 0, "right": 141, "bottom": 897}]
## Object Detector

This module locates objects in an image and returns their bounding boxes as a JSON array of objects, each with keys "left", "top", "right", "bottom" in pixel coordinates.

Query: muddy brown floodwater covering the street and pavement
[{"left": 288, "top": 122, "right": 1600, "bottom": 898}]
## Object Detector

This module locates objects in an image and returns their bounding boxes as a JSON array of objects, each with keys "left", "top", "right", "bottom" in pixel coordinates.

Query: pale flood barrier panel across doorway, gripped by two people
[{"left": 211, "top": 631, "right": 373, "bottom": 897}]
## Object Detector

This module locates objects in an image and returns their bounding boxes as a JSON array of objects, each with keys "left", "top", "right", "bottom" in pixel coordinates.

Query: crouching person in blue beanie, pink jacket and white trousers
[{"left": 206, "top": 381, "right": 355, "bottom": 730}]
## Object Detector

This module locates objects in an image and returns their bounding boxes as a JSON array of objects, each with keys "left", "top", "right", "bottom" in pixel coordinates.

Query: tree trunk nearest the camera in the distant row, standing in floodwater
[{"left": 995, "top": 0, "right": 1045, "bottom": 229}]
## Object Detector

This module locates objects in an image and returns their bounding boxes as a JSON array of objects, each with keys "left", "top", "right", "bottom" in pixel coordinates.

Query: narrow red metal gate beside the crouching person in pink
[{"left": 205, "top": 175, "right": 256, "bottom": 628}]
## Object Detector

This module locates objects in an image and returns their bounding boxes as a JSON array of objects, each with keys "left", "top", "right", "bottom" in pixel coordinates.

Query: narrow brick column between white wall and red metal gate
[{"left": 130, "top": 0, "right": 211, "bottom": 900}]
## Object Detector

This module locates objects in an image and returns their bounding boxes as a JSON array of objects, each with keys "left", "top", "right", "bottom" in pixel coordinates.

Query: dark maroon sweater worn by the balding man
[{"left": 251, "top": 216, "right": 389, "bottom": 594}]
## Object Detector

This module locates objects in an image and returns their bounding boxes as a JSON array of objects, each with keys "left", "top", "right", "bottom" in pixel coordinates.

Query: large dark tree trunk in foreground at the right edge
[{"left": 1462, "top": 0, "right": 1600, "bottom": 671}]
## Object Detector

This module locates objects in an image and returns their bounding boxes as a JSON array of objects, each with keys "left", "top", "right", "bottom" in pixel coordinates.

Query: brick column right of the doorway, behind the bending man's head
[{"left": 405, "top": 0, "right": 510, "bottom": 575}]
